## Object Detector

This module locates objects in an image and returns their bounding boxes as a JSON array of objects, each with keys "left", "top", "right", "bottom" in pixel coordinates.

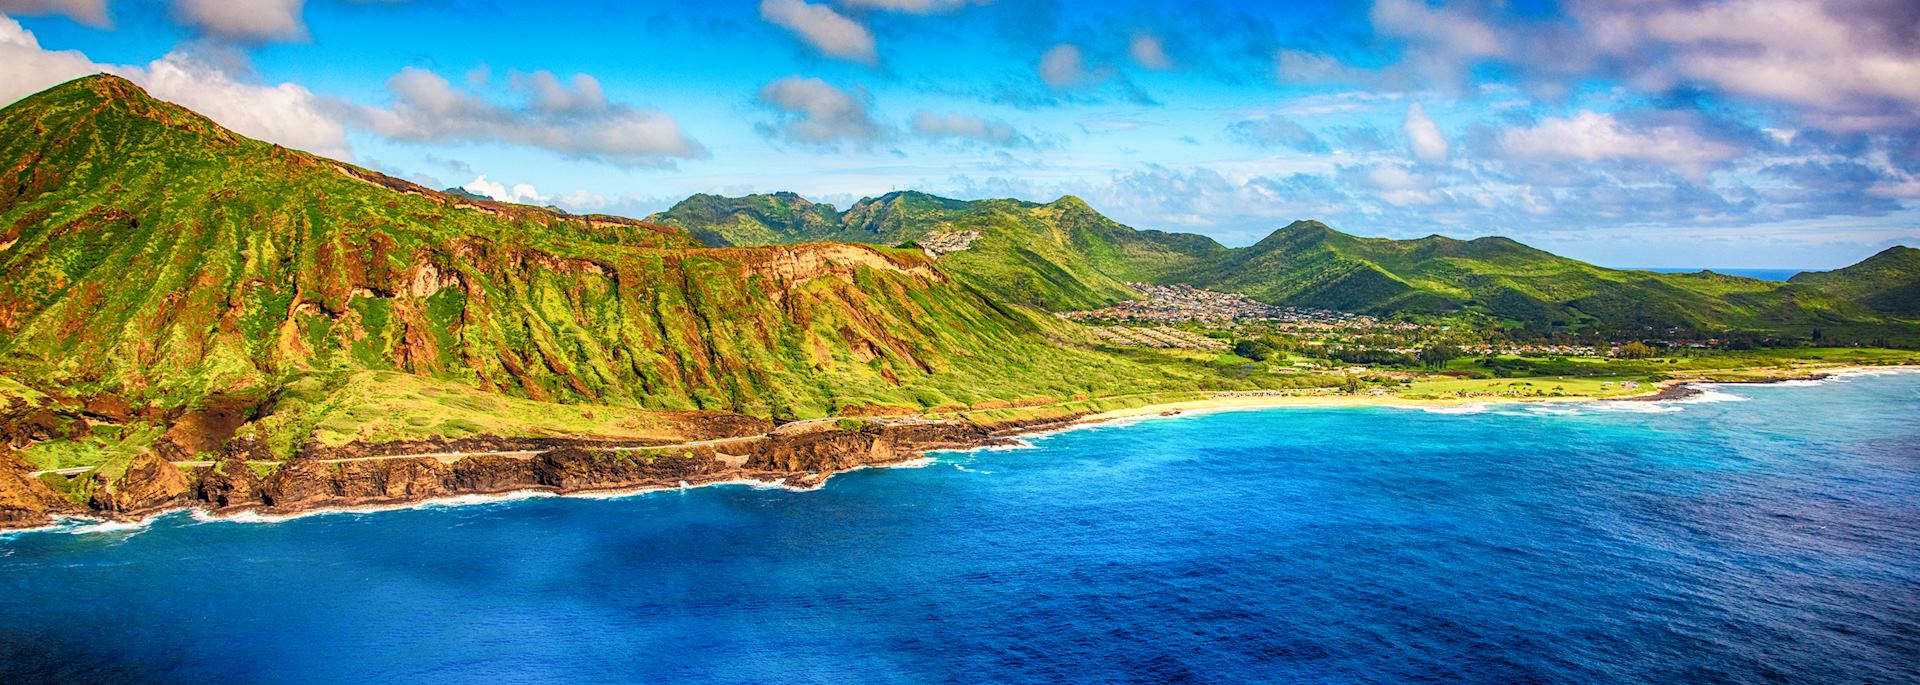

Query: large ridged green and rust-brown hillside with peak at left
[{"left": 0, "top": 77, "right": 1244, "bottom": 437}]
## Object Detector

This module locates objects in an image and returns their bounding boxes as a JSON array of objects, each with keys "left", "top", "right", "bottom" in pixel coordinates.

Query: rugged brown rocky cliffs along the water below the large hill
[{"left": 0, "top": 408, "right": 1081, "bottom": 531}]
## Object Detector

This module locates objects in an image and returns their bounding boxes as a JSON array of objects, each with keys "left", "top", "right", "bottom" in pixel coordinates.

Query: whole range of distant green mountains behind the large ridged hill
[{"left": 649, "top": 192, "right": 1920, "bottom": 334}]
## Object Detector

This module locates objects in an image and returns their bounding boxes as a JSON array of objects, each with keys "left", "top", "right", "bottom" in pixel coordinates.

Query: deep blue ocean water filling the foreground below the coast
[{"left": 0, "top": 374, "right": 1920, "bottom": 685}]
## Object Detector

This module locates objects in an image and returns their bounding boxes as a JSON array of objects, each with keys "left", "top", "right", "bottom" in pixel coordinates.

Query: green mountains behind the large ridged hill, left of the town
[{"left": 649, "top": 192, "right": 1225, "bottom": 311}]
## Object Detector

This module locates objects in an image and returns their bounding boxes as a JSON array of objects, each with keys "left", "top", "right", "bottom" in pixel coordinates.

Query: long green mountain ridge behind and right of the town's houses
[{"left": 1175, "top": 221, "right": 1884, "bottom": 330}]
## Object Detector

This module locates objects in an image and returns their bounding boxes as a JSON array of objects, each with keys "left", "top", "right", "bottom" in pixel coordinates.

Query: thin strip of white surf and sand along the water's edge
[{"left": 11, "top": 366, "right": 1920, "bottom": 539}]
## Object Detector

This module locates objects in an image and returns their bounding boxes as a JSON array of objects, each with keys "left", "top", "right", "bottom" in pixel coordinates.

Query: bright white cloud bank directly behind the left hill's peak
[{"left": 0, "top": 15, "right": 351, "bottom": 159}]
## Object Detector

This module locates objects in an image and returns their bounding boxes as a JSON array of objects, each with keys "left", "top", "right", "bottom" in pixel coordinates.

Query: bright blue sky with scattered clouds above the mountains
[{"left": 0, "top": 0, "right": 1920, "bottom": 269}]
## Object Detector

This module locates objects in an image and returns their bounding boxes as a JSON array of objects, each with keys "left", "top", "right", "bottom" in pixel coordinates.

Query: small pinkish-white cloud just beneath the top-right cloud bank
[{"left": 1500, "top": 111, "right": 1741, "bottom": 171}]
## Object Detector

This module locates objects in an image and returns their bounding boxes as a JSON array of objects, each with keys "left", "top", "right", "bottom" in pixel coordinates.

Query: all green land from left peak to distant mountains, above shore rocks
[{"left": 0, "top": 77, "right": 1920, "bottom": 485}]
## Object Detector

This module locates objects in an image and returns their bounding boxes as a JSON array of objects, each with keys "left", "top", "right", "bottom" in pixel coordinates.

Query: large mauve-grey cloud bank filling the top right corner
[{"left": 1275, "top": 0, "right": 1920, "bottom": 139}]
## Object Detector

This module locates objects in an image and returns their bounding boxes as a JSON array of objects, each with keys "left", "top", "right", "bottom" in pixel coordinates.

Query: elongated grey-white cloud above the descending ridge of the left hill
[{"left": 346, "top": 67, "right": 707, "bottom": 165}]
